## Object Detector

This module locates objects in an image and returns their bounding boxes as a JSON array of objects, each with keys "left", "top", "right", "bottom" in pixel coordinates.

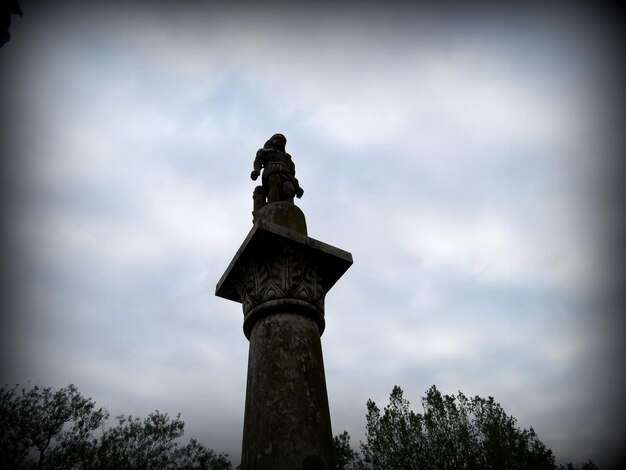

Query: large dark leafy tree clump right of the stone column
[{"left": 361, "top": 386, "right": 557, "bottom": 470}]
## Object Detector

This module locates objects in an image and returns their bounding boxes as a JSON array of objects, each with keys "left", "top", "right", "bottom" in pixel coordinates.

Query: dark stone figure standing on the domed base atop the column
[{"left": 250, "top": 134, "right": 304, "bottom": 211}]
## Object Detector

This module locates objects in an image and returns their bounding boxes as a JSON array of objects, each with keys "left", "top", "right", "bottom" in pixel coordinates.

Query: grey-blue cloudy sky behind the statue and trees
[{"left": 0, "top": 0, "right": 626, "bottom": 465}]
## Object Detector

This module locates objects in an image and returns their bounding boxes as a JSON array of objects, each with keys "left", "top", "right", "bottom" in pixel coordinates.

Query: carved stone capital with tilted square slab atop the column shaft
[{"left": 215, "top": 220, "right": 352, "bottom": 338}]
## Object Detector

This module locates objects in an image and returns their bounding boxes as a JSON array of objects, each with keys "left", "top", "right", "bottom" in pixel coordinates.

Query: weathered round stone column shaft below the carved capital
[{"left": 241, "top": 312, "right": 333, "bottom": 470}]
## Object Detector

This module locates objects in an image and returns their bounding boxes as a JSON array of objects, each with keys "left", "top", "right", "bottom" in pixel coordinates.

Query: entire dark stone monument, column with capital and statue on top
[{"left": 216, "top": 134, "right": 352, "bottom": 470}]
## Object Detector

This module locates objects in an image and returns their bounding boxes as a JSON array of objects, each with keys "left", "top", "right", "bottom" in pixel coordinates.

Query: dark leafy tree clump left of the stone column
[{"left": 0, "top": 385, "right": 232, "bottom": 470}]
